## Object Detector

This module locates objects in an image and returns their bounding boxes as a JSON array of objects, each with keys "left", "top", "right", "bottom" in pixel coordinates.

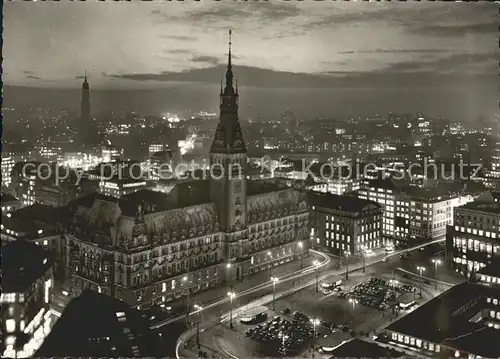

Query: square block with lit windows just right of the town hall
[{"left": 309, "top": 193, "right": 382, "bottom": 256}]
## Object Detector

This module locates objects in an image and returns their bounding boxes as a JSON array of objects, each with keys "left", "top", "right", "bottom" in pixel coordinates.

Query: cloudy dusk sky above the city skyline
[{"left": 3, "top": 1, "right": 499, "bottom": 121}]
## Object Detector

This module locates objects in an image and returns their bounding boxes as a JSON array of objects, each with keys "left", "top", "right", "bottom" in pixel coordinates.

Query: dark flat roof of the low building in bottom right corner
[{"left": 386, "top": 283, "right": 500, "bottom": 358}]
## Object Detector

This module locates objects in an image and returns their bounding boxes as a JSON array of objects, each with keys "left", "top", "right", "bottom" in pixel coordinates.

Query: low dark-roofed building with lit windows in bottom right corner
[{"left": 386, "top": 263, "right": 500, "bottom": 359}]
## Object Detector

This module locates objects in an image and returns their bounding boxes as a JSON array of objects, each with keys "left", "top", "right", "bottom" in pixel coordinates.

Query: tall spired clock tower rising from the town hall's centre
[{"left": 210, "top": 30, "right": 247, "bottom": 277}]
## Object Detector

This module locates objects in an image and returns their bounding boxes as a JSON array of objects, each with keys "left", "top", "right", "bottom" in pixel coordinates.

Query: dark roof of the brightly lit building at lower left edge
[{"left": 2, "top": 240, "right": 52, "bottom": 293}]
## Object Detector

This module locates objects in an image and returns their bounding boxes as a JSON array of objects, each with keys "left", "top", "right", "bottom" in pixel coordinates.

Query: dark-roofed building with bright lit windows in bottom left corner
[{"left": 1, "top": 240, "right": 54, "bottom": 358}]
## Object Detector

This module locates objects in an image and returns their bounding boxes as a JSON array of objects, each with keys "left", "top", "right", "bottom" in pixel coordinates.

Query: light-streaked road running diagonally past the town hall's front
[{"left": 175, "top": 239, "right": 444, "bottom": 358}]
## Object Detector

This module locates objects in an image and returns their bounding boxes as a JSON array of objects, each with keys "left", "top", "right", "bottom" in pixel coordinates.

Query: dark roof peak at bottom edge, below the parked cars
[{"left": 332, "top": 339, "right": 405, "bottom": 358}]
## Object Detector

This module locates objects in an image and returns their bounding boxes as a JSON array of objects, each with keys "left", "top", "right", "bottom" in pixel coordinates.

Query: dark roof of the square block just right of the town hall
[{"left": 309, "top": 192, "right": 382, "bottom": 213}]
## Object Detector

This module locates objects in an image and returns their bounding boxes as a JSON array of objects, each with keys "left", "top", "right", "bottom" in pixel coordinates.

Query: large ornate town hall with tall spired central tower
[{"left": 65, "top": 37, "right": 309, "bottom": 309}]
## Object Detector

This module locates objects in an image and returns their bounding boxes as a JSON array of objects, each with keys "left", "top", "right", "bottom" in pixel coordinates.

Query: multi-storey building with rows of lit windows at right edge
[{"left": 446, "top": 191, "right": 500, "bottom": 277}]
